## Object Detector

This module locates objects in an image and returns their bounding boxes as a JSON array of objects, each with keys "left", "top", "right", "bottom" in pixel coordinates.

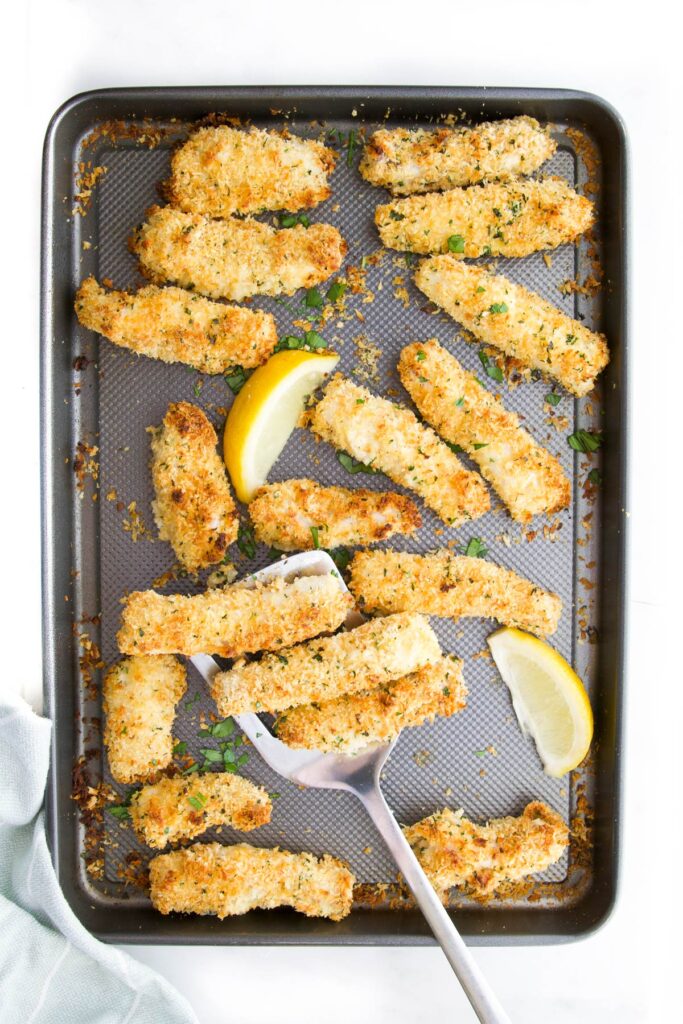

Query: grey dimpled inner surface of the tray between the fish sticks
[{"left": 62, "top": 94, "right": 601, "bottom": 929}]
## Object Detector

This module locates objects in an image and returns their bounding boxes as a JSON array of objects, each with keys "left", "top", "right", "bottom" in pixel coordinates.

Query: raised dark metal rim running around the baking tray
[{"left": 41, "top": 86, "right": 629, "bottom": 945}]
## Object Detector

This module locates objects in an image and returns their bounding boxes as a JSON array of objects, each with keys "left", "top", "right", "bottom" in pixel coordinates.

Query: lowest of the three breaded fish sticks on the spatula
[{"left": 275, "top": 655, "right": 467, "bottom": 754}]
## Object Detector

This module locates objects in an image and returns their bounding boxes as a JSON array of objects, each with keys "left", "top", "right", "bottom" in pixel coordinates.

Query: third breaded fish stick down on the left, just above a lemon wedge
[{"left": 74, "top": 278, "right": 278, "bottom": 374}]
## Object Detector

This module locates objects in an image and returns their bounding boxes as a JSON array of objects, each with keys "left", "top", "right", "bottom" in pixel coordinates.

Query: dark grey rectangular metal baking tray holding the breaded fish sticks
[{"left": 41, "top": 87, "right": 628, "bottom": 944}]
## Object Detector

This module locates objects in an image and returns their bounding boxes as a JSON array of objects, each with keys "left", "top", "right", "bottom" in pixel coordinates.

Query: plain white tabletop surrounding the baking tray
[{"left": 0, "top": 0, "right": 683, "bottom": 1024}]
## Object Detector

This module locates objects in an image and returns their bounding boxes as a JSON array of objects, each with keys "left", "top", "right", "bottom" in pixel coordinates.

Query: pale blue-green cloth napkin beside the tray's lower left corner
[{"left": 0, "top": 699, "right": 198, "bottom": 1024}]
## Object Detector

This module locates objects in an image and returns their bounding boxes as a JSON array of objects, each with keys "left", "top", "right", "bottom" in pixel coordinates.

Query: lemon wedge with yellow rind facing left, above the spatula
[{"left": 223, "top": 350, "right": 339, "bottom": 502}]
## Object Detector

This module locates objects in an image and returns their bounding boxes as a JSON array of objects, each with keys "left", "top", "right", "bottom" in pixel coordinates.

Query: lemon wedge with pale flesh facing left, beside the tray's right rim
[{"left": 487, "top": 628, "right": 593, "bottom": 778}]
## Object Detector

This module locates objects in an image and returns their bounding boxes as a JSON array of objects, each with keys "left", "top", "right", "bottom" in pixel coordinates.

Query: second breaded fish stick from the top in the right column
[{"left": 375, "top": 178, "right": 593, "bottom": 258}]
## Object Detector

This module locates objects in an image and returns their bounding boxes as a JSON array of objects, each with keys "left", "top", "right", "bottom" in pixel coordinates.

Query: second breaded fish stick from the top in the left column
[{"left": 130, "top": 206, "right": 346, "bottom": 302}]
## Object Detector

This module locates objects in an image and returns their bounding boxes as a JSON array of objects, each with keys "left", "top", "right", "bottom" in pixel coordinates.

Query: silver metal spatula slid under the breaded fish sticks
[{"left": 191, "top": 551, "right": 510, "bottom": 1024}]
